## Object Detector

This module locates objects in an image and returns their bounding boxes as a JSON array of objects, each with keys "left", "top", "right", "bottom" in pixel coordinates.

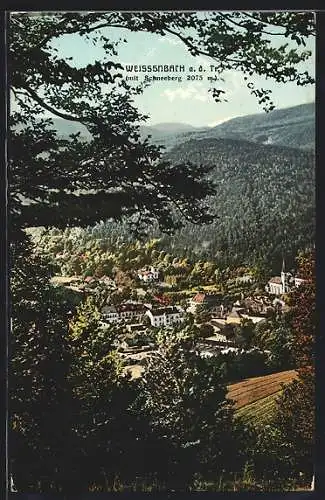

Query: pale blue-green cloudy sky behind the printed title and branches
[{"left": 36, "top": 13, "right": 315, "bottom": 127}]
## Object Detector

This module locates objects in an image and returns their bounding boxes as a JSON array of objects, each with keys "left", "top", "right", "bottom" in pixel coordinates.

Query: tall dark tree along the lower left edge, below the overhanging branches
[{"left": 9, "top": 235, "right": 72, "bottom": 492}]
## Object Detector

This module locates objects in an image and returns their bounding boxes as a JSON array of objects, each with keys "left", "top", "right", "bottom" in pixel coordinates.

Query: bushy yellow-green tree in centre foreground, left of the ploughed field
[{"left": 134, "top": 331, "right": 237, "bottom": 487}]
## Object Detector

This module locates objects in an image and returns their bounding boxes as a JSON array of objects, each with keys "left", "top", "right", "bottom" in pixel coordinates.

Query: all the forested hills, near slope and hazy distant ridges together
[{"left": 17, "top": 103, "right": 315, "bottom": 271}]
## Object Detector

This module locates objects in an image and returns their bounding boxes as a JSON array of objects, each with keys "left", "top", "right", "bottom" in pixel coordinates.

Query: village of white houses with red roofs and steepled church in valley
[{"left": 52, "top": 263, "right": 304, "bottom": 378}]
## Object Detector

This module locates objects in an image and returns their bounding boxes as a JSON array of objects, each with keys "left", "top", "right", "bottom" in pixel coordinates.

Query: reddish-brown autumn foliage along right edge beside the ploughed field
[{"left": 275, "top": 252, "right": 316, "bottom": 481}]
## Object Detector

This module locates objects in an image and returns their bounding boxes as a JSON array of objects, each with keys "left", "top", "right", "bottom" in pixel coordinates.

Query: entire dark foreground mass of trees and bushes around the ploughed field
[{"left": 10, "top": 235, "right": 312, "bottom": 492}]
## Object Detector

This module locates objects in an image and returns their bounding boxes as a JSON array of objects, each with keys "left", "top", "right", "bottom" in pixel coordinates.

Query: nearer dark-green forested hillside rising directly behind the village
[{"left": 161, "top": 139, "right": 315, "bottom": 267}]
